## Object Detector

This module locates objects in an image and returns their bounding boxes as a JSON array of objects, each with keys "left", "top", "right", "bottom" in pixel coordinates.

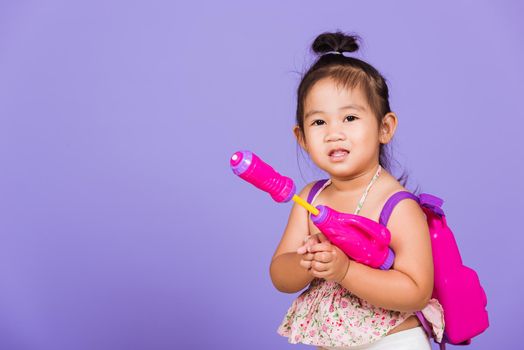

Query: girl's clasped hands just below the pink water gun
[{"left": 309, "top": 235, "right": 350, "bottom": 283}]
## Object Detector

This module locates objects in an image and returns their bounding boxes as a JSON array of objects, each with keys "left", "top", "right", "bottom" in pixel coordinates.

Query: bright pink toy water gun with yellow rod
[{"left": 230, "top": 151, "right": 395, "bottom": 270}]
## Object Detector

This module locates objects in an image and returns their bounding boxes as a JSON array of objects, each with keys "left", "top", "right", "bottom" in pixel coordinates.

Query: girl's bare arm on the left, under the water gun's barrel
[{"left": 269, "top": 183, "right": 314, "bottom": 293}]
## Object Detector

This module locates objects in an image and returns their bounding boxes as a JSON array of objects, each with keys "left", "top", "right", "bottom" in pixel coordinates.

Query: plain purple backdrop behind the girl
[{"left": 0, "top": 0, "right": 524, "bottom": 350}]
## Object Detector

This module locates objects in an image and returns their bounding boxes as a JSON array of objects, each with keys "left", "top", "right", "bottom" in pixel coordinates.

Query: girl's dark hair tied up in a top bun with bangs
[{"left": 296, "top": 31, "right": 407, "bottom": 189}]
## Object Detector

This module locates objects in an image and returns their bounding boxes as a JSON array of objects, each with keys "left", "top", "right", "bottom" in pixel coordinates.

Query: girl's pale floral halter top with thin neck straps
[{"left": 277, "top": 166, "right": 444, "bottom": 347}]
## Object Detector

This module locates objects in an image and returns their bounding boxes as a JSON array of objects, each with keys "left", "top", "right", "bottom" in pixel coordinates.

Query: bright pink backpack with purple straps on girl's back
[{"left": 308, "top": 180, "right": 489, "bottom": 349}]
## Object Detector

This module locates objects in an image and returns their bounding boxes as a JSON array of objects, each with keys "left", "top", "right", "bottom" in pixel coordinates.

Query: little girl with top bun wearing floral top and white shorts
[{"left": 270, "top": 32, "right": 444, "bottom": 350}]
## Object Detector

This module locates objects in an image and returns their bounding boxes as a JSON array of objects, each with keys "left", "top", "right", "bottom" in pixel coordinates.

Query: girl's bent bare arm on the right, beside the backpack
[{"left": 340, "top": 200, "right": 433, "bottom": 312}]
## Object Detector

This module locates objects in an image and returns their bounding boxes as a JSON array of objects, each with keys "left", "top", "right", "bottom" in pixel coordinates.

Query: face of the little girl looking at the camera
[{"left": 295, "top": 78, "right": 380, "bottom": 179}]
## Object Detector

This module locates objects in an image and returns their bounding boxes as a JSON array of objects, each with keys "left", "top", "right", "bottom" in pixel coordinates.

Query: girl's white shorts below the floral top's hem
[{"left": 318, "top": 327, "right": 431, "bottom": 350}]
